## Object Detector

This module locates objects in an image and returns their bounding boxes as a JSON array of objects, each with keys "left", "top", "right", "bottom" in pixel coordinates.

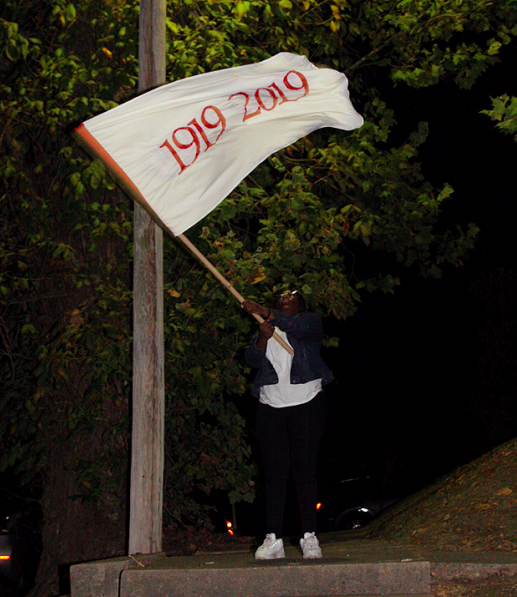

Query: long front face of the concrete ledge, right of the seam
[{"left": 119, "top": 562, "right": 431, "bottom": 597}]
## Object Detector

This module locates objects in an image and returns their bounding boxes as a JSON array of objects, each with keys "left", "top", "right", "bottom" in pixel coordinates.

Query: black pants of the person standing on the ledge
[{"left": 257, "top": 392, "right": 327, "bottom": 537}]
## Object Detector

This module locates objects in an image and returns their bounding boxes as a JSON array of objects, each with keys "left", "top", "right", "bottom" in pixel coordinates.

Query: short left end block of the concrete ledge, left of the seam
[{"left": 70, "top": 553, "right": 165, "bottom": 597}]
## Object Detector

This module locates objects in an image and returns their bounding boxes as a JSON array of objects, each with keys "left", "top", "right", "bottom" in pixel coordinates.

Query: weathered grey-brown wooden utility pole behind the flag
[{"left": 128, "top": 0, "right": 166, "bottom": 555}]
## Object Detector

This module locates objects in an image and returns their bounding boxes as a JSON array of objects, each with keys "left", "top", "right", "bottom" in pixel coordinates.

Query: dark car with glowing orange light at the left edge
[{"left": 0, "top": 488, "right": 39, "bottom": 597}]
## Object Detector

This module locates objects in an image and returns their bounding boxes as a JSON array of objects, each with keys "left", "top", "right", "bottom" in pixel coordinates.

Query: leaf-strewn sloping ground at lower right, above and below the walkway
[{"left": 368, "top": 439, "right": 517, "bottom": 597}]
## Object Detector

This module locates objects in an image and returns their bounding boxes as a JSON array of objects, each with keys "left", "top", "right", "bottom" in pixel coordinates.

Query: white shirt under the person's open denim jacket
[{"left": 259, "top": 327, "right": 321, "bottom": 408}]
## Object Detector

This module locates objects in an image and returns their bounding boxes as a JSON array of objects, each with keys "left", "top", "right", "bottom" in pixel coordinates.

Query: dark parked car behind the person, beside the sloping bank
[{"left": 318, "top": 477, "right": 404, "bottom": 532}]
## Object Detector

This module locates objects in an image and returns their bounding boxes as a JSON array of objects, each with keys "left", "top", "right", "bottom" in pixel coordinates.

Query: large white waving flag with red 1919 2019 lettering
[{"left": 76, "top": 52, "right": 363, "bottom": 235}]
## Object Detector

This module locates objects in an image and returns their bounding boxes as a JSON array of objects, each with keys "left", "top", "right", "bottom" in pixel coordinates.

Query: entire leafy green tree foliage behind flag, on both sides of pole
[{"left": 0, "top": 0, "right": 516, "bottom": 595}]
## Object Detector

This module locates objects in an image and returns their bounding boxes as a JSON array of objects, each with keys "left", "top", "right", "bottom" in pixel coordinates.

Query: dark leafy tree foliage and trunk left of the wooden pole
[{"left": 0, "top": 2, "right": 139, "bottom": 595}]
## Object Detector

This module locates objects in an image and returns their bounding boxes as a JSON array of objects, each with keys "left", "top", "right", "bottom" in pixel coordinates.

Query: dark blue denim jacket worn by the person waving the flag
[{"left": 245, "top": 310, "right": 334, "bottom": 398}]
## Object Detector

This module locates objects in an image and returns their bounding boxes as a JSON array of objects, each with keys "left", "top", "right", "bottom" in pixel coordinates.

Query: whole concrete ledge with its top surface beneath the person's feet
[{"left": 70, "top": 537, "right": 517, "bottom": 597}]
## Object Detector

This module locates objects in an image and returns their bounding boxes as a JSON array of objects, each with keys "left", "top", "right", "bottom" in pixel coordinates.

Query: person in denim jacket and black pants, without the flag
[{"left": 242, "top": 291, "right": 334, "bottom": 560}]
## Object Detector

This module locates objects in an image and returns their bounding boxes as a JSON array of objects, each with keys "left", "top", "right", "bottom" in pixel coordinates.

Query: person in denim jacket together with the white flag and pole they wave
[{"left": 73, "top": 52, "right": 364, "bottom": 559}]
